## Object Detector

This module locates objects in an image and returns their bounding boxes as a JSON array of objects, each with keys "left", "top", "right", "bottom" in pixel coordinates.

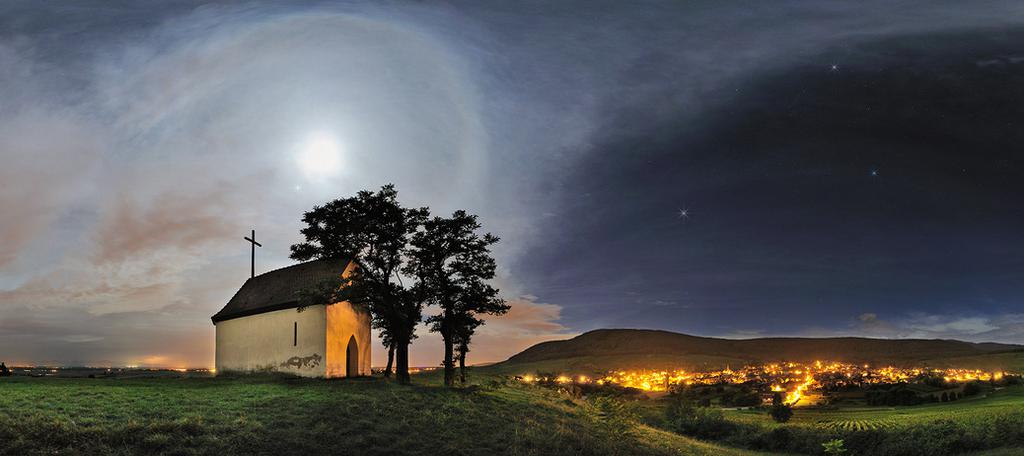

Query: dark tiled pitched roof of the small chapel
[{"left": 211, "top": 259, "right": 349, "bottom": 323}]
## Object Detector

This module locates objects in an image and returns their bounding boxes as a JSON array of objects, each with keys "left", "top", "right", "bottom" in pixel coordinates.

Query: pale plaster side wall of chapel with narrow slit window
[{"left": 216, "top": 305, "right": 325, "bottom": 377}]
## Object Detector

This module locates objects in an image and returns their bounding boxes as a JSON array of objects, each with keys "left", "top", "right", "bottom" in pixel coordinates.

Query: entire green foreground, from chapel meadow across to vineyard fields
[{"left": 0, "top": 373, "right": 1024, "bottom": 456}]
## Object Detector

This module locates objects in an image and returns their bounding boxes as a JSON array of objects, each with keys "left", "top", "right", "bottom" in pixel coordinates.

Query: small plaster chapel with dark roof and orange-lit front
[{"left": 212, "top": 259, "right": 371, "bottom": 377}]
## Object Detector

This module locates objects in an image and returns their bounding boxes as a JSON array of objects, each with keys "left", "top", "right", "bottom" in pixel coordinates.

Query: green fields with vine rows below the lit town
[{"left": 643, "top": 386, "right": 1024, "bottom": 456}]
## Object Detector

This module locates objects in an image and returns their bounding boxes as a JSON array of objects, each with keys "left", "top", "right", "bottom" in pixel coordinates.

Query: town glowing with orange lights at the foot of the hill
[{"left": 518, "top": 361, "right": 1008, "bottom": 405}]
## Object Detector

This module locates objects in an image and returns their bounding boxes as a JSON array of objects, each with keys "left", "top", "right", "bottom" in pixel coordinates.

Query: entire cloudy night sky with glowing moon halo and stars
[{"left": 0, "top": 1, "right": 1024, "bottom": 367}]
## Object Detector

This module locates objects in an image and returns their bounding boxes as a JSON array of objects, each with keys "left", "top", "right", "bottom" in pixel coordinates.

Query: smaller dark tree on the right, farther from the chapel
[{"left": 404, "top": 210, "right": 509, "bottom": 386}]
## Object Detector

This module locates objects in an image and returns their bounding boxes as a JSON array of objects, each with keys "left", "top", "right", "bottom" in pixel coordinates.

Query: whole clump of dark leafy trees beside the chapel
[{"left": 291, "top": 184, "right": 510, "bottom": 386}]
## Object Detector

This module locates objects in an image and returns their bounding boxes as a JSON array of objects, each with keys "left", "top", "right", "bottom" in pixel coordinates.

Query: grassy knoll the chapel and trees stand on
[{"left": 0, "top": 376, "right": 770, "bottom": 455}]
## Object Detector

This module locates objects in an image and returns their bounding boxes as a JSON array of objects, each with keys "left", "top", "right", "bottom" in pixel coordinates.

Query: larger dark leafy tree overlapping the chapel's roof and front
[{"left": 291, "top": 184, "right": 428, "bottom": 383}]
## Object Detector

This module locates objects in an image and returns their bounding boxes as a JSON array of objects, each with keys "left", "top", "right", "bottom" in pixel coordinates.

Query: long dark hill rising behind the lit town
[{"left": 490, "top": 329, "right": 1024, "bottom": 373}]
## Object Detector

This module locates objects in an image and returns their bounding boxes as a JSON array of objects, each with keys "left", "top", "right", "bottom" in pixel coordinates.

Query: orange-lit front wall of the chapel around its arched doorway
[{"left": 327, "top": 302, "right": 372, "bottom": 377}]
